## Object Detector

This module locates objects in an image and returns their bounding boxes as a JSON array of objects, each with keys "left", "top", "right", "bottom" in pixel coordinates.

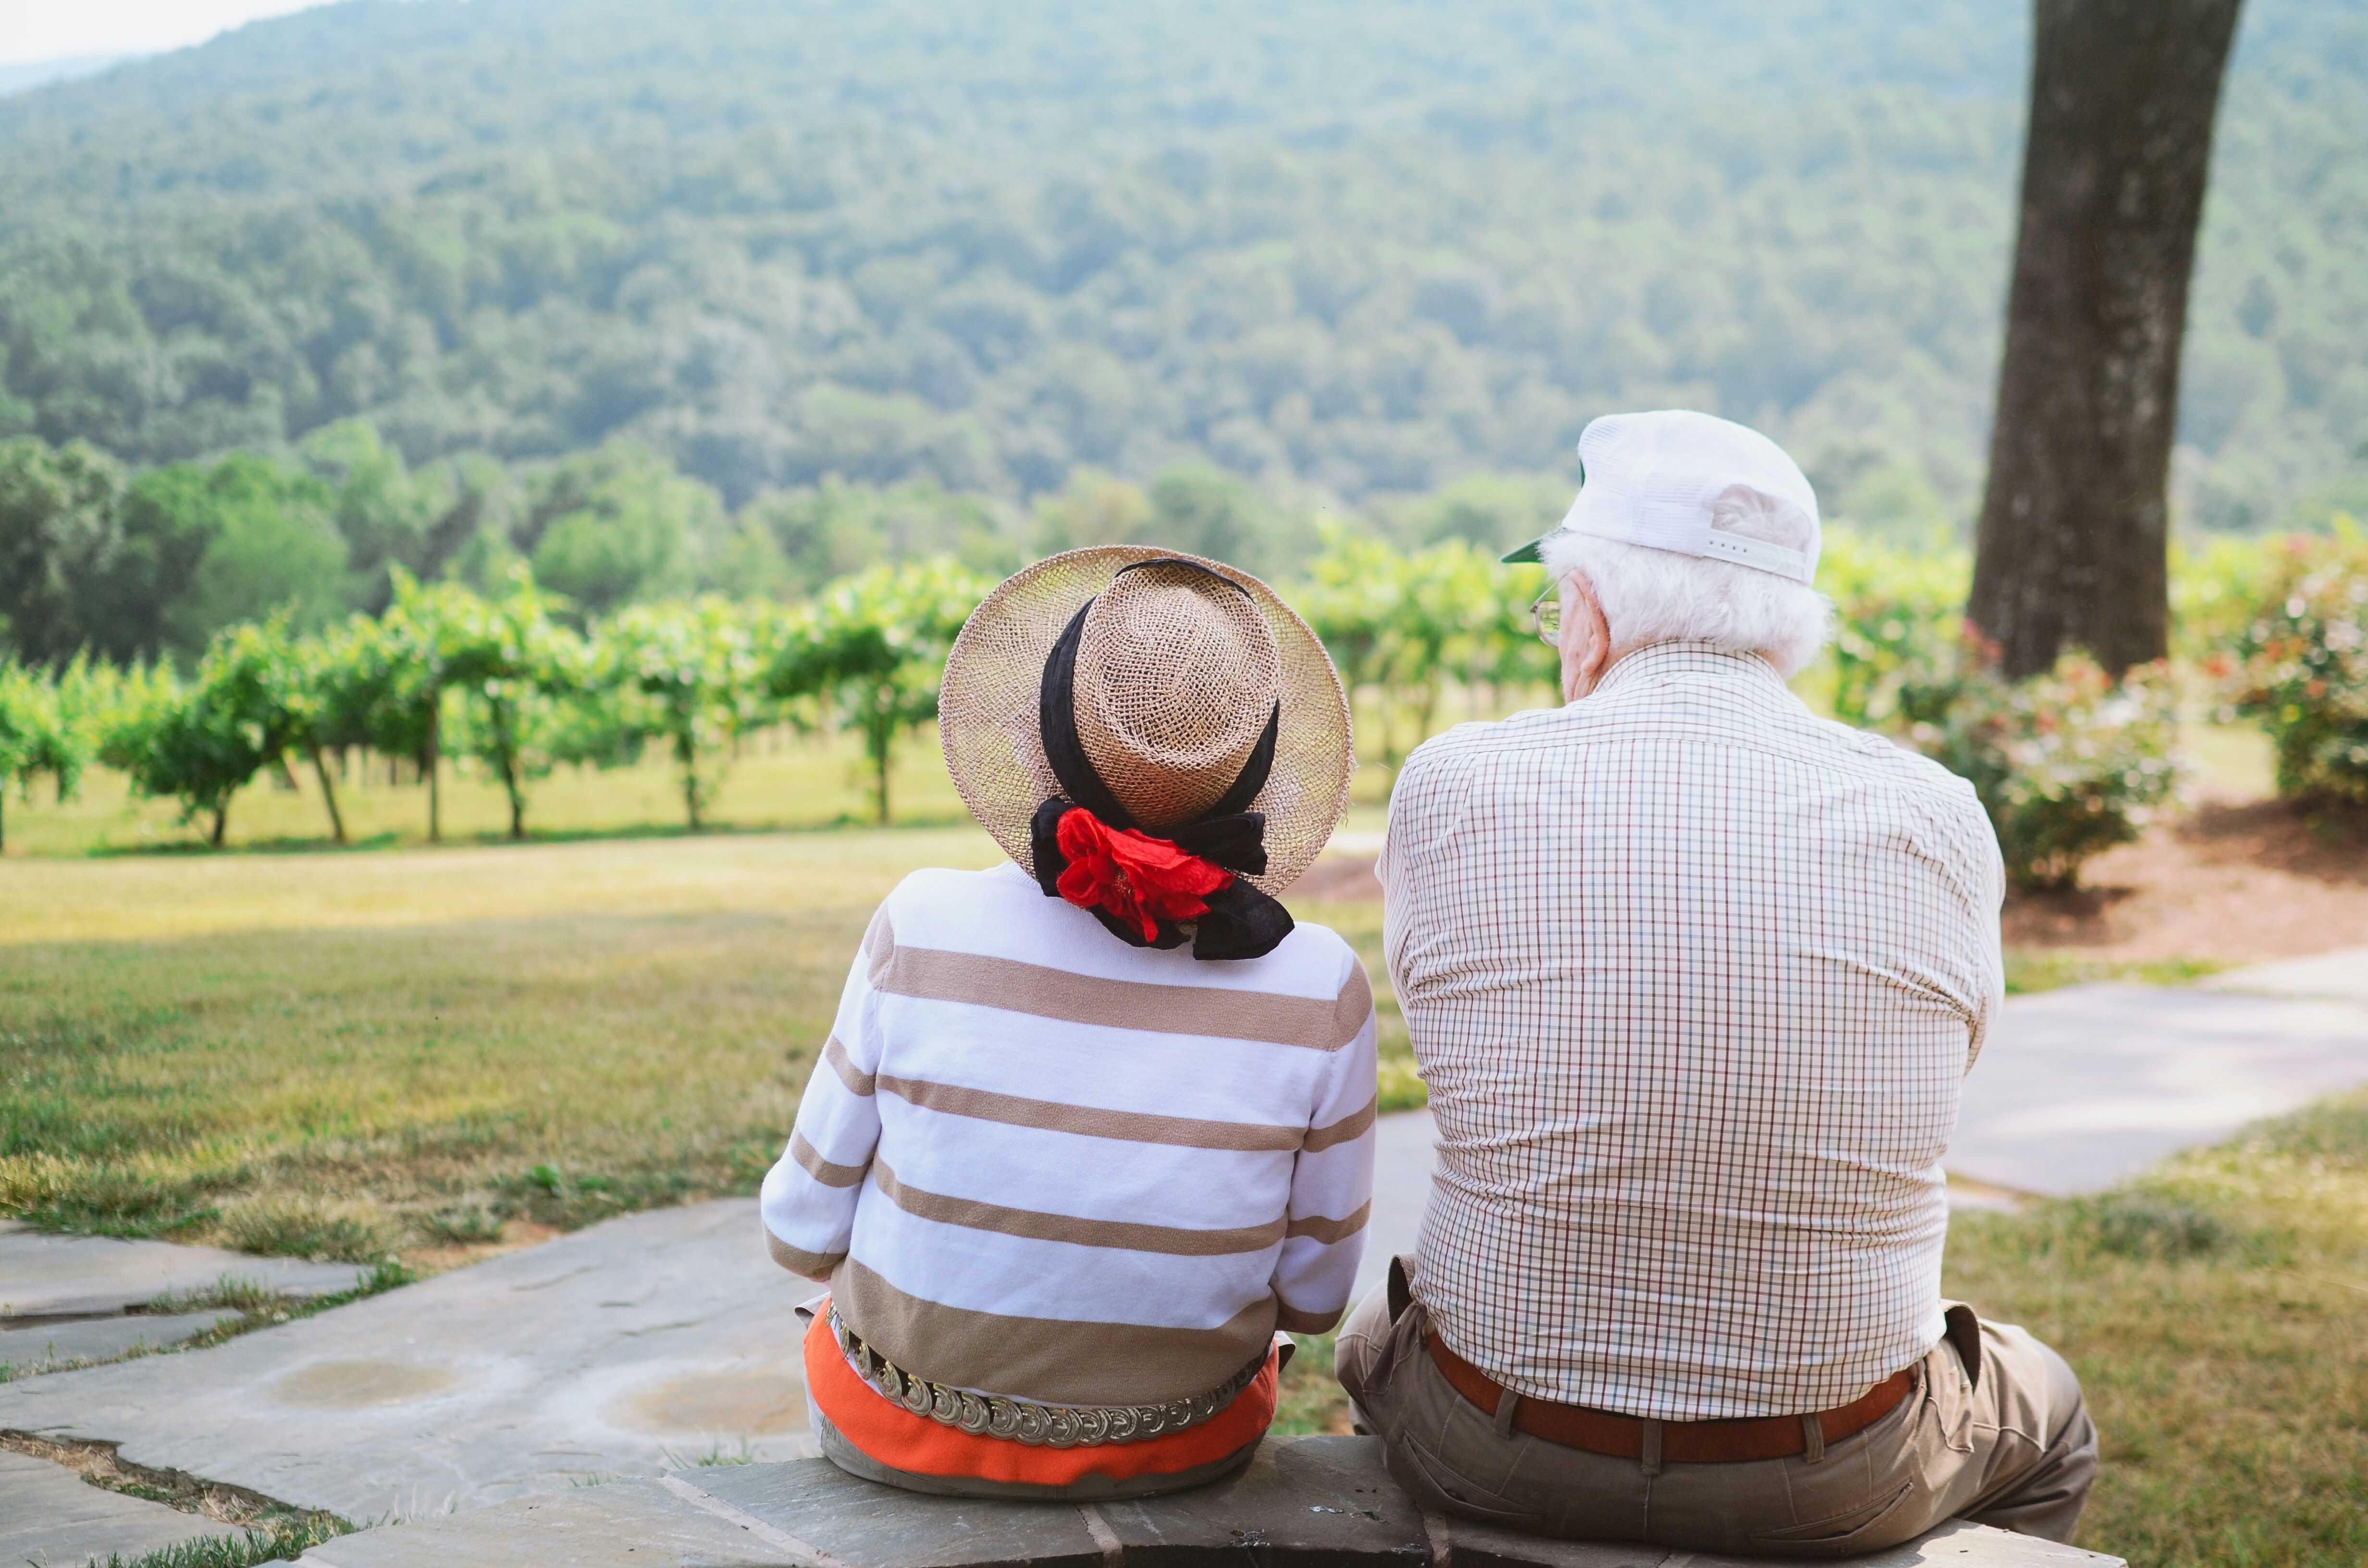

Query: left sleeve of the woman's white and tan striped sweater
[{"left": 758, "top": 905, "right": 895, "bottom": 1279}]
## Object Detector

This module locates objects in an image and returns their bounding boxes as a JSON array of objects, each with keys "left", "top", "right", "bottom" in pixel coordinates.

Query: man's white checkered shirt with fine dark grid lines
[{"left": 1381, "top": 642, "right": 2006, "bottom": 1421}]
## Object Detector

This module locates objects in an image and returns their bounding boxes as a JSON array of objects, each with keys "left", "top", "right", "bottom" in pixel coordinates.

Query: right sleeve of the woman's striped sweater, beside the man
[{"left": 1274, "top": 955, "right": 1381, "bottom": 1334}]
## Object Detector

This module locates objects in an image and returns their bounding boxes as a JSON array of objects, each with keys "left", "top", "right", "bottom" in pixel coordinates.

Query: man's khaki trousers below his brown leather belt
[{"left": 1333, "top": 1270, "right": 2096, "bottom": 1556}]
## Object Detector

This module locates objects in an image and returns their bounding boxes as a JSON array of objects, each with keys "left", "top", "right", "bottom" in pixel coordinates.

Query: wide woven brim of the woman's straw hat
[{"left": 937, "top": 545, "right": 1357, "bottom": 893}]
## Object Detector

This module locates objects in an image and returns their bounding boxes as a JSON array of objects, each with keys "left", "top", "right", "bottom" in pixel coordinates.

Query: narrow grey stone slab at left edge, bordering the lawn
[{"left": 0, "top": 1220, "right": 365, "bottom": 1319}]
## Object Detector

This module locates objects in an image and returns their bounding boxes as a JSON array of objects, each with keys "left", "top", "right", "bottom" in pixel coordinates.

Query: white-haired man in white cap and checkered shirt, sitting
[{"left": 1338, "top": 412, "right": 2096, "bottom": 1556}]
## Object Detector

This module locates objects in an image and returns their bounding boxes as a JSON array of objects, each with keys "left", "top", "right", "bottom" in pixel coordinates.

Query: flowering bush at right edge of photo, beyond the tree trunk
[{"left": 2212, "top": 528, "right": 2368, "bottom": 805}]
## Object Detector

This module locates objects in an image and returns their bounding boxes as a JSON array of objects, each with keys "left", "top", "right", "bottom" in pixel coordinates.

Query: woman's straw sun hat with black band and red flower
[{"left": 937, "top": 545, "right": 1357, "bottom": 959}]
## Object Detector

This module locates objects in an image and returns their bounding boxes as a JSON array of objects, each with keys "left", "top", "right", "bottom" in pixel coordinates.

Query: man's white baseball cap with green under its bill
[{"left": 1504, "top": 407, "right": 1819, "bottom": 583}]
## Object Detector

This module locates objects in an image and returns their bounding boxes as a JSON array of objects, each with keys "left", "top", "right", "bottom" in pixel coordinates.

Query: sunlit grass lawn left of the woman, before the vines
[{"left": 0, "top": 829, "right": 1421, "bottom": 1267}]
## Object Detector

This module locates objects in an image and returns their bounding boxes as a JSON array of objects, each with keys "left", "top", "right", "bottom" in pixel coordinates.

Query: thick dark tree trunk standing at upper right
[{"left": 1968, "top": 0, "right": 2240, "bottom": 677}]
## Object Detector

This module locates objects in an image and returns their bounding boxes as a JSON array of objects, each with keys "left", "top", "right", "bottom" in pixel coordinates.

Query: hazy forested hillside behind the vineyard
[{"left": 0, "top": 0, "right": 2368, "bottom": 545}]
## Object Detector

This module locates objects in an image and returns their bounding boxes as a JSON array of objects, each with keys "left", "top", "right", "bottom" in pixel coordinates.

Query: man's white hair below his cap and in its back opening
[{"left": 1544, "top": 490, "right": 1833, "bottom": 677}]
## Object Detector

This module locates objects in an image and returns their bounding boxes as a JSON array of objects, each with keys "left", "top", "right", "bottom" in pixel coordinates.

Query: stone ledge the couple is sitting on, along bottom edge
[{"left": 303, "top": 1438, "right": 2120, "bottom": 1568}]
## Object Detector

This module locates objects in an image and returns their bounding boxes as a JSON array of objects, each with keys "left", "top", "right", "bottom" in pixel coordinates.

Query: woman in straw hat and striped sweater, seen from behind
[{"left": 763, "top": 547, "right": 1376, "bottom": 1499}]
